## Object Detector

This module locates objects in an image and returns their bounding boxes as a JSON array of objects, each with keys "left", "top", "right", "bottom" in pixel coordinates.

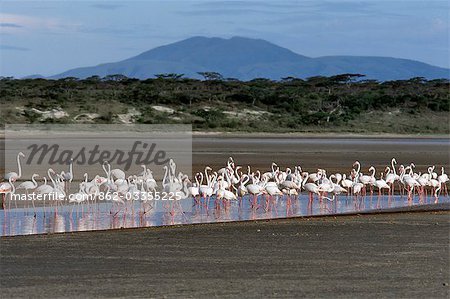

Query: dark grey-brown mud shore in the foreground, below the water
[{"left": 0, "top": 204, "right": 450, "bottom": 298}]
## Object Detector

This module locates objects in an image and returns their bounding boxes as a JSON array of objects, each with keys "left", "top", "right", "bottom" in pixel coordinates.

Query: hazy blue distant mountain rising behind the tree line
[{"left": 50, "top": 37, "right": 450, "bottom": 81}]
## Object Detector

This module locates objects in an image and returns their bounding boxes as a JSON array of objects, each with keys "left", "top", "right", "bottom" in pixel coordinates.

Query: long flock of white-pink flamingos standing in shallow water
[{"left": 0, "top": 152, "right": 449, "bottom": 218}]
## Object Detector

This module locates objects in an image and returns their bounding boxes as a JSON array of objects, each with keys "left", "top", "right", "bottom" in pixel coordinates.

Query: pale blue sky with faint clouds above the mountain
[{"left": 0, "top": 0, "right": 450, "bottom": 77}]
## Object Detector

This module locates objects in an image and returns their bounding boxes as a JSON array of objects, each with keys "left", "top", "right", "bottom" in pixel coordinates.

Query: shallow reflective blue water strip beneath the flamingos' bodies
[{"left": 0, "top": 194, "right": 450, "bottom": 236}]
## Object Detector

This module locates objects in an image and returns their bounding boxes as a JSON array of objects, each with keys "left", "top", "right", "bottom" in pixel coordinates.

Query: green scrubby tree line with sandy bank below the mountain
[{"left": 0, "top": 72, "right": 450, "bottom": 134}]
